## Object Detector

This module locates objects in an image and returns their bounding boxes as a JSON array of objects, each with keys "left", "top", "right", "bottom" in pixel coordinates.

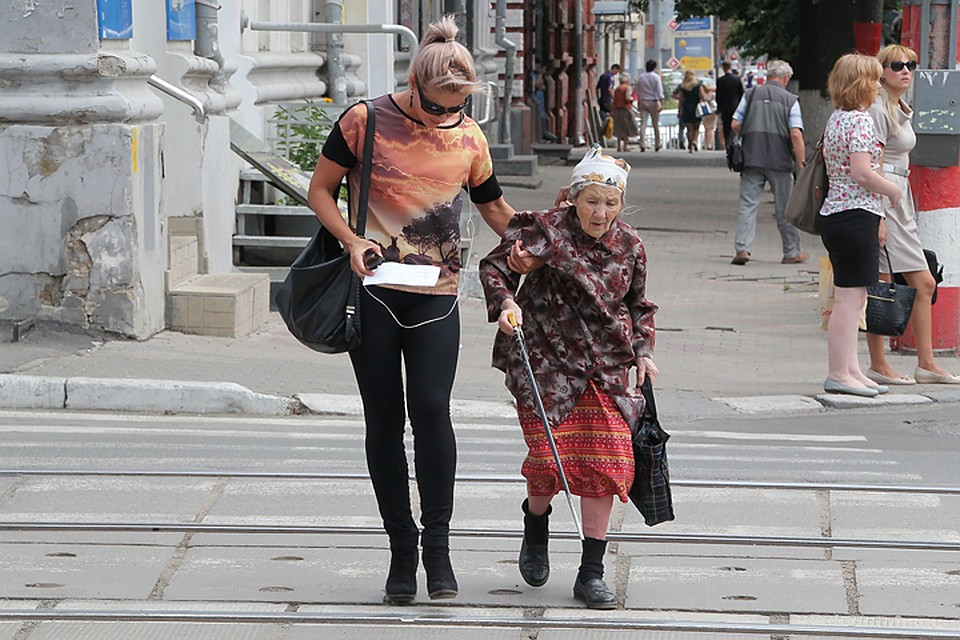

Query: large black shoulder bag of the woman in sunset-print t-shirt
[{"left": 277, "top": 100, "right": 376, "bottom": 353}]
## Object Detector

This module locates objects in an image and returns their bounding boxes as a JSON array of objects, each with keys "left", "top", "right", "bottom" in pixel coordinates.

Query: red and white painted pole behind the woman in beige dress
[{"left": 892, "top": 0, "right": 960, "bottom": 352}]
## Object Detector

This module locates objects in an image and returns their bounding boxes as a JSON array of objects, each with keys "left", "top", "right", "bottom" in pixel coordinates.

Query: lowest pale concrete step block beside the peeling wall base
[{"left": 167, "top": 273, "right": 270, "bottom": 338}]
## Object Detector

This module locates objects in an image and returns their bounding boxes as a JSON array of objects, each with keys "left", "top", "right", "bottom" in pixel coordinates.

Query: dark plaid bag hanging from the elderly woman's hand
[{"left": 628, "top": 378, "right": 675, "bottom": 527}]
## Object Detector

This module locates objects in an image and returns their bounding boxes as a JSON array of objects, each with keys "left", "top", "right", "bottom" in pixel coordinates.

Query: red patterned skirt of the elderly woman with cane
[{"left": 519, "top": 382, "right": 633, "bottom": 502}]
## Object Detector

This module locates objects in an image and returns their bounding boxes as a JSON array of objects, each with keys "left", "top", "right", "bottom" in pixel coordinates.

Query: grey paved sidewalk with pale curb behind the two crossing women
[{"left": 0, "top": 150, "right": 960, "bottom": 417}]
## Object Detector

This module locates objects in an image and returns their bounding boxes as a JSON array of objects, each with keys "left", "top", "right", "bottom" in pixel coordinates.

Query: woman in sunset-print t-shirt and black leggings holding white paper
[{"left": 309, "top": 17, "right": 514, "bottom": 604}]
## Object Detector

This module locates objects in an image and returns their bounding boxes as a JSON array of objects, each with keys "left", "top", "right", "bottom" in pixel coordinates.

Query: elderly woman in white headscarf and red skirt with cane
[{"left": 480, "top": 148, "right": 658, "bottom": 609}]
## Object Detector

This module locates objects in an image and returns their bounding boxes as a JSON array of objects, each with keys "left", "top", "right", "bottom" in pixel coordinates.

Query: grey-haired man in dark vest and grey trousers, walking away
[{"left": 731, "top": 60, "right": 810, "bottom": 265}]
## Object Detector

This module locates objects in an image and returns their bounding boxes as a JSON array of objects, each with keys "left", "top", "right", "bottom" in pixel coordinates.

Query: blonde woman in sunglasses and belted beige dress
[{"left": 867, "top": 44, "right": 960, "bottom": 385}]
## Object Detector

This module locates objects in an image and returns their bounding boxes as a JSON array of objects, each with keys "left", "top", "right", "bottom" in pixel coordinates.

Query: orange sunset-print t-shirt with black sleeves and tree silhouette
[{"left": 323, "top": 95, "right": 502, "bottom": 295}]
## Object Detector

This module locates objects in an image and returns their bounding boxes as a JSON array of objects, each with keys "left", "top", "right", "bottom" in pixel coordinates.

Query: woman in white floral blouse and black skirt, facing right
[{"left": 820, "top": 53, "right": 903, "bottom": 397}]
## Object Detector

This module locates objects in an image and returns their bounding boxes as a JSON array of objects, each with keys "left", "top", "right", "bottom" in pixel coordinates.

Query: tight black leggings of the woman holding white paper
[{"left": 350, "top": 287, "right": 460, "bottom": 549}]
